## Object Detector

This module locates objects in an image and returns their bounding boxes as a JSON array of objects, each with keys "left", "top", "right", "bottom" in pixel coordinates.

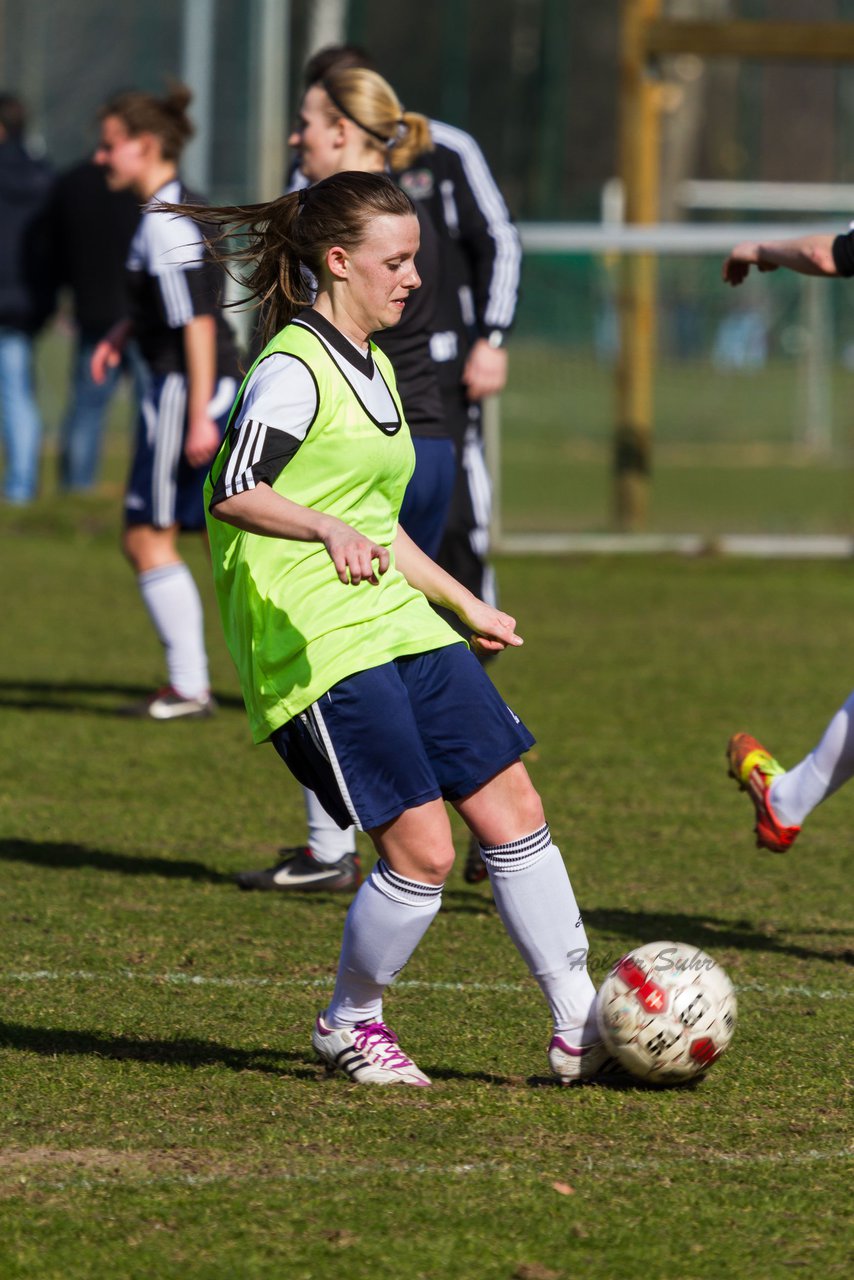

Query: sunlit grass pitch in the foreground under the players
[{"left": 0, "top": 476, "right": 854, "bottom": 1280}]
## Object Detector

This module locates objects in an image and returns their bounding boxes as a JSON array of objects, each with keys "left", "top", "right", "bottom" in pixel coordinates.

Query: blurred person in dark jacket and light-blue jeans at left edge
[{"left": 0, "top": 93, "right": 54, "bottom": 503}]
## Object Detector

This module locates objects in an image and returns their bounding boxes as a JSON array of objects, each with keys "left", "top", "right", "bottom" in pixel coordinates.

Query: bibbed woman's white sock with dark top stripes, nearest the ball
[{"left": 480, "top": 826, "right": 600, "bottom": 1046}]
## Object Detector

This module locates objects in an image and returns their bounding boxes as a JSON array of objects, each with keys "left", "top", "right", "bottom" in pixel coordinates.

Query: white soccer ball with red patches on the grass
[{"left": 597, "top": 942, "right": 736, "bottom": 1084}]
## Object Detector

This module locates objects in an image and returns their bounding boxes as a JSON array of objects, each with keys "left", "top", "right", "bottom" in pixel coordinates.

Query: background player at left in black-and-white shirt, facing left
[{"left": 92, "top": 86, "right": 238, "bottom": 721}]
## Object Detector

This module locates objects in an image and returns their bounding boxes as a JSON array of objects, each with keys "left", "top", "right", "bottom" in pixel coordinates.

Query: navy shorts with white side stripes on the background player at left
[{"left": 124, "top": 374, "right": 237, "bottom": 530}]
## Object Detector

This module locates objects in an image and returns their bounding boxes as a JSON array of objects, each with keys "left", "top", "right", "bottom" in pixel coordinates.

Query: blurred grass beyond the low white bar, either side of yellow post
[{"left": 501, "top": 339, "right": 854, "bottom": 538}]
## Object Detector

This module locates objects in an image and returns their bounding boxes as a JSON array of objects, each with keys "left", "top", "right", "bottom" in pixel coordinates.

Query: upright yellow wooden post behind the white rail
[{"left": 615, "top": 0, "right": 661, "bottom": 531}]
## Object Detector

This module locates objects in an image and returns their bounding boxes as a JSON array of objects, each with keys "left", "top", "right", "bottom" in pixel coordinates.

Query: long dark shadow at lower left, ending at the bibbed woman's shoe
[{"left": 0, "top": 1020, "right": 318, "bottom": 1080}]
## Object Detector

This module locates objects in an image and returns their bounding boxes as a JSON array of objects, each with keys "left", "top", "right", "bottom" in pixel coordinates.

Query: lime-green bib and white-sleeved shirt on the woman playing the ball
[{"left": 205, "top": 311, "right": 460, "bottom": 742}]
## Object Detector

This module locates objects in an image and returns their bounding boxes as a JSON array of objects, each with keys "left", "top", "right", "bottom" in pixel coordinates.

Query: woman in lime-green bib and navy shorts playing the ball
[{"left": 179, "top": 173, "right": 604, "bottom": 1085}]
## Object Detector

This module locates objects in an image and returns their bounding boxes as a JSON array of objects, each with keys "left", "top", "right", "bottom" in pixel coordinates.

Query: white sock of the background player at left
[{"left": 137, "top": 561, "right": 210, "bottom": 698}]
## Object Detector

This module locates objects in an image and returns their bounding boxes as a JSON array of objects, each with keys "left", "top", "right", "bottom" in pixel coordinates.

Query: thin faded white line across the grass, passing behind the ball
[{"left": 0, "top": 969, "right": 854, "bottom": 1000}]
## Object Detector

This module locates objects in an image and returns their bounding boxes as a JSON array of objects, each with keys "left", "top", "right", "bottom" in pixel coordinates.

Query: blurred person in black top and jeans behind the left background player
[{"left": 49, "top": 160, "right": 140, "bottom": 492}]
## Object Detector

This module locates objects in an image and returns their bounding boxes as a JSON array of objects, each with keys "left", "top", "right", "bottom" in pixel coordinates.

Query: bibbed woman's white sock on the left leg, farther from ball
[{"left": 324, "top": 858, "right": 443, "bottom": 1027}]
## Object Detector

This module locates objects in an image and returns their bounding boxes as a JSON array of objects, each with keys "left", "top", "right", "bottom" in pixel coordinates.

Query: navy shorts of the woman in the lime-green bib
[{"left": 271, "top": 644, "right": 534, "bottom": 831}]
